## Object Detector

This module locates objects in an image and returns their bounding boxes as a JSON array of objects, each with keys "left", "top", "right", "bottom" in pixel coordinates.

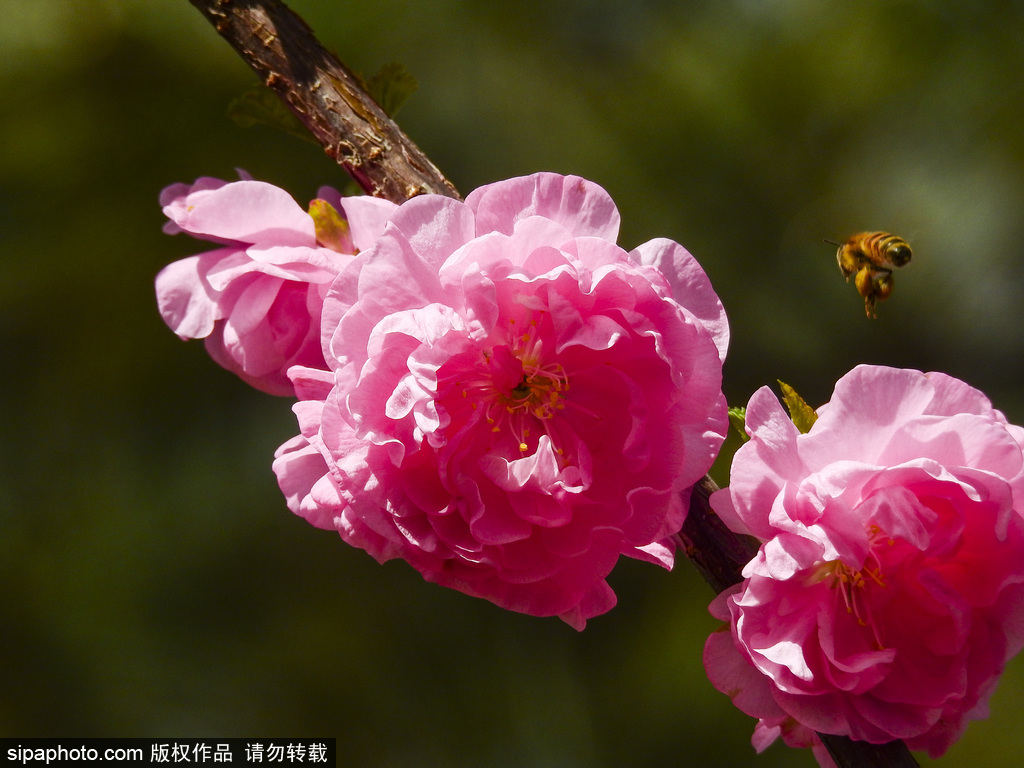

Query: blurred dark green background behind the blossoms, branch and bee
[{"left": 0, "top": 0, "right": 1024, "bottom": 768}]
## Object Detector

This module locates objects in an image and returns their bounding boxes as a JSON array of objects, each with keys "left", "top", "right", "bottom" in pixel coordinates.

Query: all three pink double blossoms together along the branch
[{"left": 157, "top": 173, "right": 1024, "bottom": 766}]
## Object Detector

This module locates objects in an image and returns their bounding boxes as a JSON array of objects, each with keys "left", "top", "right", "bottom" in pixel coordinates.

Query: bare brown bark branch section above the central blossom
[{"left": 189, "top": 0, "right": 459, "bottom": 203}]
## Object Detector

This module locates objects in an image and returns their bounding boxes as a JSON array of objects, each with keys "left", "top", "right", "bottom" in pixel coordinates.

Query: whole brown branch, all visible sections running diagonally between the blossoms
[{"left": 189, "top": 0, "right": 918, "bottom": 768}]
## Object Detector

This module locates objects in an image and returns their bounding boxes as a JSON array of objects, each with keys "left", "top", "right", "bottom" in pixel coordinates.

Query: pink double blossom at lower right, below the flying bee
[{"left": 705, "top": 366, "right": 1024, "bottom": 757}]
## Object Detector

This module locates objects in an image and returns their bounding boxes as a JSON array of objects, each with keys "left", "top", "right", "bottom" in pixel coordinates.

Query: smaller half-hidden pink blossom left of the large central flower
[{"left": 157, "top": 178, "right": 396, "bottom": 395}]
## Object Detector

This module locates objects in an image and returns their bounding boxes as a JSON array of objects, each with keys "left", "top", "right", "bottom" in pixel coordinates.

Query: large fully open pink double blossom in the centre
[{"left": 274, "top": 173, "right": 728, "bottom": 629}]
